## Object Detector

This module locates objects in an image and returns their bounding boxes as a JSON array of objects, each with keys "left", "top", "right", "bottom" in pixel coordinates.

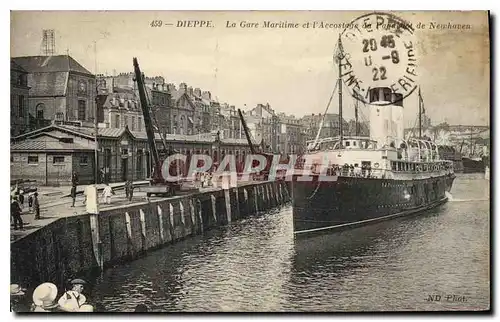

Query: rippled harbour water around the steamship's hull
[{"left": 89, "top": 174, "right": 490, "bottom": 312}]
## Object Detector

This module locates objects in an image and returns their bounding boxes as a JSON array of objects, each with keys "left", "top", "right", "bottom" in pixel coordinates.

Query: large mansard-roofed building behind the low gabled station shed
[{"left": 12, "top": 55, "right": 96, "bottom": 129}]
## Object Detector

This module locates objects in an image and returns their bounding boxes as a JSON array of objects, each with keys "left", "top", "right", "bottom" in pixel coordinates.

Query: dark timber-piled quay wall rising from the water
[{"left": 11, "top": 181, "right": 291, "bottom": 289}]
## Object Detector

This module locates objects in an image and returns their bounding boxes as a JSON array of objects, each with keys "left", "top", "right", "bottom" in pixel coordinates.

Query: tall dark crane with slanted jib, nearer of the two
[{"left": 133, "top": 57, "right": 181, "bottom": 197}]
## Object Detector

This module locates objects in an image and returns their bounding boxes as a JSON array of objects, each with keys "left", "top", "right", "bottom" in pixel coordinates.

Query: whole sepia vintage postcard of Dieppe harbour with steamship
[{"left": 10, "top": 11, "right": 491, "bottom": 312}]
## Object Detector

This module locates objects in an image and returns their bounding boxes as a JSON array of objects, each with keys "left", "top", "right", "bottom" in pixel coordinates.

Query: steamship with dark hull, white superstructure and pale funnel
[{"left": 291, "top": 73, "right": 455, "bottom": 237}]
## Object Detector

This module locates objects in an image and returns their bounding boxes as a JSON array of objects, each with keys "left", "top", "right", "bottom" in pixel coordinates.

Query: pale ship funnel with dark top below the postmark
[{"left": 368, "top": 87, "right": 404, "bottom": 148}]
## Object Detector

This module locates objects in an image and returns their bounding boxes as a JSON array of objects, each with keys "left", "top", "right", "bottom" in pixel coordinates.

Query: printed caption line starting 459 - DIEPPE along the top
[{"left": 150, "top": 20, "right": 472, "bottom": 30}]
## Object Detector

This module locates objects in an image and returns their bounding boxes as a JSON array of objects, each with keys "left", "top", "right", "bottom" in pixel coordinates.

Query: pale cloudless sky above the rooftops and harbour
[{"left": 11, "top": 11, "right": 490, "bottom": 127}]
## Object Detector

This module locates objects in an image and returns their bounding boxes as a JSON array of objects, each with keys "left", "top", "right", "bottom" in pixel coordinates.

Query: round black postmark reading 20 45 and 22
[{"left": 338, "top": 12, "right": 418, "bottom": 104}]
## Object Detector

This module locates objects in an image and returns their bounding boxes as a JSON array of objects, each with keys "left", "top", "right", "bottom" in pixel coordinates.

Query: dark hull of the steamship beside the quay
[{"left": 291, "top": 174, "right": 455, "bottom": 236}]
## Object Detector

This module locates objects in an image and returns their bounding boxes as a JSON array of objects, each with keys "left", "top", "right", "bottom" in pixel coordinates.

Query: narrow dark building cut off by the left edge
[{"left": 10, "top": 60, "right": 30, "bottom": 136}]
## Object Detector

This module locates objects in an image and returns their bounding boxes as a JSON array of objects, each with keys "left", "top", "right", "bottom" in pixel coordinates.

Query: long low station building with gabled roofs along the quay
[{"left": 10, "top": 124, "right": 254, "bottom": 185}]
